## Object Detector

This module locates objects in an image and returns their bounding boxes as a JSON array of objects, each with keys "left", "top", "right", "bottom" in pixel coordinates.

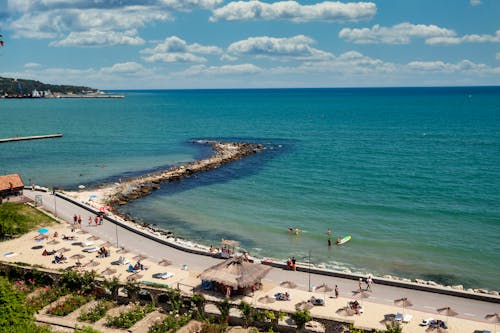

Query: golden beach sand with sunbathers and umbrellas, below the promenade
[{"left": 0, "top": 217, "right": 494, "bottom": 333}]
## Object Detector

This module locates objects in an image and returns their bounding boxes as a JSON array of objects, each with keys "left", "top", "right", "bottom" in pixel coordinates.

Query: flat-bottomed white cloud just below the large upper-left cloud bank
[{"left": 49, "top": 30, "right": 145, "bottom": 47}]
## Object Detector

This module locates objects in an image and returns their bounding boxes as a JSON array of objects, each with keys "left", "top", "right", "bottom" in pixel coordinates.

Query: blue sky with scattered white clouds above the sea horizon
[{"left": 0, "top": 0, "right": 500, "bottom": 90}]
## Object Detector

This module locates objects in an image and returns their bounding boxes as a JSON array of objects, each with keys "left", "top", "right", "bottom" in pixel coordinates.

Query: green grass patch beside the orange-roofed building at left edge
[{"left": 0, "top": 202, "right": 54, "bottom": 240}]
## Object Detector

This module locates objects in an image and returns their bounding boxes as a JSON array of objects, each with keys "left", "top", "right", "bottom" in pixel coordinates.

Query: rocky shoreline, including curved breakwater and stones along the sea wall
[{"left": 58, "top": 140, "right": 499, "bottom": 296}]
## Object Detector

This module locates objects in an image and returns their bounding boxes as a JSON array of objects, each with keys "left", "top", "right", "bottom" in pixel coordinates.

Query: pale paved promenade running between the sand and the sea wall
[{"left": 24, "top": 190, "right": 500, "bottom": 322}]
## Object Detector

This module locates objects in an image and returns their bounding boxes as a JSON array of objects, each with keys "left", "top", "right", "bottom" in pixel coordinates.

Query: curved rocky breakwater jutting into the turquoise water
[{"left": 107, "top": 140, "right": 264, "bottom": 207}]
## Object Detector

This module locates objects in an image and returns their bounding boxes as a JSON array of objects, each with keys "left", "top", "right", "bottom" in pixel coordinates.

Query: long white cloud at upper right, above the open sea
[{"left": 339, "top": 22, "right": 455, "bottom": 44}]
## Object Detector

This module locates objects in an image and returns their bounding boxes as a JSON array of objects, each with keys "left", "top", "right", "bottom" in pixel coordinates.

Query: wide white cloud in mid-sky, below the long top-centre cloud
[{"left": 227, "top": 35, "right": 332, "bottom": 60}]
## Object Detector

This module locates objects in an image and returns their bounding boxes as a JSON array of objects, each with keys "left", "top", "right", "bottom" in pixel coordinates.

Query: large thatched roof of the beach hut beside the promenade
[{"left": 199, "top": 257, "right": 271, "bottom": 289}]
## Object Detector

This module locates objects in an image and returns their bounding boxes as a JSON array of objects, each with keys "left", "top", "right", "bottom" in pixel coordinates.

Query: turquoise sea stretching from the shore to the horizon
[{"left": 0, "top": 87, "right": 500, "bottom": 290}]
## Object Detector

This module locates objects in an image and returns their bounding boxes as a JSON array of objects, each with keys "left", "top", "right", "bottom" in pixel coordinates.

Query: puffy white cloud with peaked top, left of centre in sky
[{"left": 141, "top": 36, "right": 222, "bottom": 63}]
